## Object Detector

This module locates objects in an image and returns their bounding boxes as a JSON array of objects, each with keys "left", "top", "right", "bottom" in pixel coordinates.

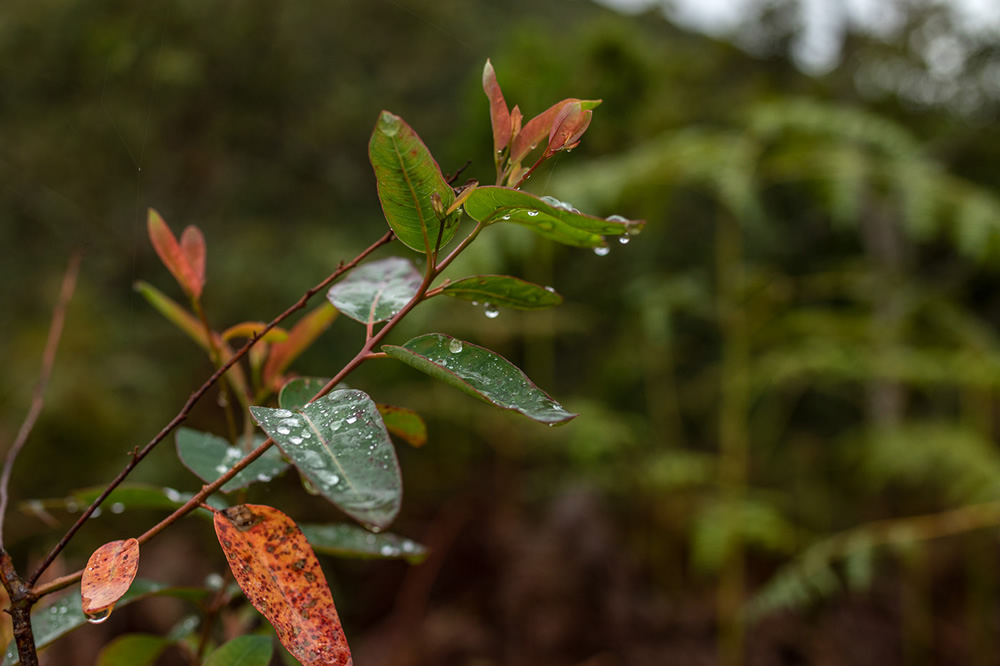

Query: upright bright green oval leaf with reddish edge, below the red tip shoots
[{"left": 368, "top": 111, "right": 459, "bottom": 253}]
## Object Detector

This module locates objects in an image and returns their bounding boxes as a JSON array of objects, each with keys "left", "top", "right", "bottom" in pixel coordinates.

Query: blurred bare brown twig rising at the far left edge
[{"left": 0, "top": 251, "right": 83, "bottom": 547}]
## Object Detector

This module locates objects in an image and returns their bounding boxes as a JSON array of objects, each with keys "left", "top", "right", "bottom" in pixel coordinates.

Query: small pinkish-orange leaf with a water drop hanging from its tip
[{"left": 80, "top": 539, "right": 139, "bottom": 622}]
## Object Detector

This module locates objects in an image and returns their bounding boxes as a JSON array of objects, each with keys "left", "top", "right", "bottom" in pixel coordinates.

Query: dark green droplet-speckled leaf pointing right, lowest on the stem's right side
[{"left": 382, "top": 333, "right": 576, "bottom": 424}]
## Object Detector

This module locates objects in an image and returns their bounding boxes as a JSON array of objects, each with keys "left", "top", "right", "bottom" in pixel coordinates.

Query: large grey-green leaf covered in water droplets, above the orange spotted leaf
[{"left": 250, "top": 389, "right": 403, "bottom": 529}]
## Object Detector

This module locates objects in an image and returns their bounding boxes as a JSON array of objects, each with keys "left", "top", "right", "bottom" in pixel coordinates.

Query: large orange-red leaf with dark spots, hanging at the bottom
[{"left": 215, "top": 504, "right": 353, "bottom": 666}]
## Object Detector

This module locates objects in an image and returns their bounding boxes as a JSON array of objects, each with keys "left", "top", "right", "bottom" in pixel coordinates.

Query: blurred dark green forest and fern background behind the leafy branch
[{"left": 0, "top": 0, "right": 1000, "bottom": 664}]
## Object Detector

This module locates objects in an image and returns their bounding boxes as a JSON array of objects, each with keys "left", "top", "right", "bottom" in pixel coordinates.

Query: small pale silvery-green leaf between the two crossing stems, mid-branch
[{"left": 326, "top": 257, "right": 423, "bottom": 324}]
